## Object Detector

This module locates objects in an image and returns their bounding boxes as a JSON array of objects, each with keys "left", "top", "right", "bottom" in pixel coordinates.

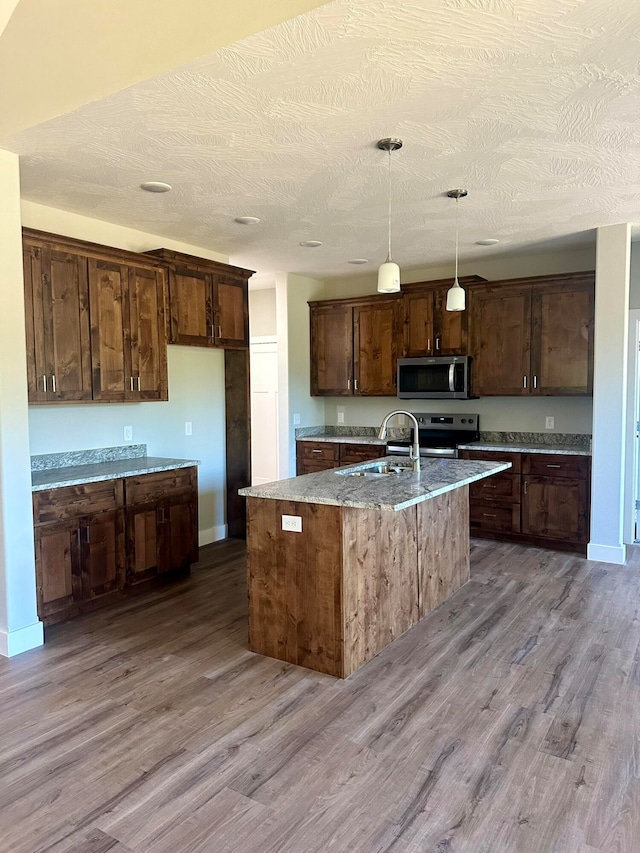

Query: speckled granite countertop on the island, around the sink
[{"left": 239, "top": 456, "right": 511, "bottom": 511}]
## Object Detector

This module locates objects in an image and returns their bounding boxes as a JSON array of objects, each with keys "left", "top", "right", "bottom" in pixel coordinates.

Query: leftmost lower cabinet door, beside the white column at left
[{"left": 35, "top": 519, "right": 82, "bottom": 619}]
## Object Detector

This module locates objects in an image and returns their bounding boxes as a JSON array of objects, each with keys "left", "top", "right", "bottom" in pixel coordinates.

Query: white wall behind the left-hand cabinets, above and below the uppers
[{"left": 22, "top": 202, "right": 227, "bottom": 544}]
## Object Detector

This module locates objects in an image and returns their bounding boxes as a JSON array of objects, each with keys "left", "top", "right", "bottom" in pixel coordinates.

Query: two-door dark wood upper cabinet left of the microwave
[{"left": 310, "top": 297, "right": 400, "bottom": 397}]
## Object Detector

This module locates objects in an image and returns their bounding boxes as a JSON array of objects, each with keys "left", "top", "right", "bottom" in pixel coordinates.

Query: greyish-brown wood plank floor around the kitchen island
[{"left": 0, "top": 541, "right": 640, "bottom": 853}]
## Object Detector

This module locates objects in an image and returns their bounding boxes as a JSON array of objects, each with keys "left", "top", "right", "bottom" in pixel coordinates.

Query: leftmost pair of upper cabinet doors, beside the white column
[{"left": 23, "top": 245, "right": 91, "bottom": 403}]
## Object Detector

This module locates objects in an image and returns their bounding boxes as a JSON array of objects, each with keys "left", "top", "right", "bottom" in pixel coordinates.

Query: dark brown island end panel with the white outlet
[{"left": 247, "top": 498, "right": 343, "bottom": 677}]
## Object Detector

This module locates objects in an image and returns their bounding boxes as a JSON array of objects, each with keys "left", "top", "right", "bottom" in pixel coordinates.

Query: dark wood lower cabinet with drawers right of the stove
[{"left": 461, "top": 450, "right": 591, "bottom": 553}]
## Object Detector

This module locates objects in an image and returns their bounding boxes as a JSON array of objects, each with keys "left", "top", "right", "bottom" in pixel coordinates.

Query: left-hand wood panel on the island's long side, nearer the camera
[{"left": 343, "top": 507, "right": 419, "bottom": 678}]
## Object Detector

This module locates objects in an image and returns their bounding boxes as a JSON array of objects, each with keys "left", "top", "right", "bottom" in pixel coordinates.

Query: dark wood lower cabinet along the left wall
[{"left": 33, "top": 467, "right": 198, "bottom": 624}]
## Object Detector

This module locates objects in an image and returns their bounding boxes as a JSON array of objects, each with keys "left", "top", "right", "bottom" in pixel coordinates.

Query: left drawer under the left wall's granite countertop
[{"left": 33, "top": 480, "right": 123, "bottom": 524}]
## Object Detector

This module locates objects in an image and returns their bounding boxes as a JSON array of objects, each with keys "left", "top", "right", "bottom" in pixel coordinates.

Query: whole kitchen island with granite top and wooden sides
[{"left": 240, "top": 457, "right": 510, "bottom": 678}]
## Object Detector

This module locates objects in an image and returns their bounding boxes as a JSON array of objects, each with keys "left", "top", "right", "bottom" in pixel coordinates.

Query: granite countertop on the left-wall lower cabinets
[{"left": 31, "top": 456, "right": 199, "bottom": 492}]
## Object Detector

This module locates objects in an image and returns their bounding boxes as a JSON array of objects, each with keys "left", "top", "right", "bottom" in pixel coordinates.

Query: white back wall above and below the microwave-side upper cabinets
[{"left": 322, "top": 245, "right": 596, "bottom": 433}]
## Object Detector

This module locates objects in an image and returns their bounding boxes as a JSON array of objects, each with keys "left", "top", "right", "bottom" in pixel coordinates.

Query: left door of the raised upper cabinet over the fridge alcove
[{"left": 169, "top": 267, "right": 214, "bottom": 347}]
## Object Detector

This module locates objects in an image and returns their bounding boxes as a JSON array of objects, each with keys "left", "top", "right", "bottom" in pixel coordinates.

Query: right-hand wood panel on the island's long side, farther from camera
[{"left": 416, "top": 486, "right": 469, "bottom": 618}]
